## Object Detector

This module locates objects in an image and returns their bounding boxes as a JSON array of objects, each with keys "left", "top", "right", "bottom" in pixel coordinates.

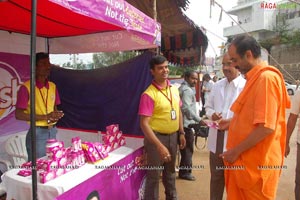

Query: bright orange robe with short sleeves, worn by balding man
[{"left": 225, "top": 65, "right": 290, "bottom": 200}]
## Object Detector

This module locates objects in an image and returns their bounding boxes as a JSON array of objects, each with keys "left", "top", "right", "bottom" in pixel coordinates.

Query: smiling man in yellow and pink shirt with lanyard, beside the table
[{"left": 139, "top": 56, "right": 185, "bottom": 200}]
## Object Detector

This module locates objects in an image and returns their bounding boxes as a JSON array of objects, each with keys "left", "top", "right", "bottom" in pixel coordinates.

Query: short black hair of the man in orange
[{"left": 231, "top": 34, "right": 261, "bottom": 58}]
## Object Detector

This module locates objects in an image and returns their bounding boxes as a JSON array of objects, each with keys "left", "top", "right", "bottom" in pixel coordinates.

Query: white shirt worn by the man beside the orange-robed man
[{"left": 205, "top": 75, "right": 246, "bottom": 153}]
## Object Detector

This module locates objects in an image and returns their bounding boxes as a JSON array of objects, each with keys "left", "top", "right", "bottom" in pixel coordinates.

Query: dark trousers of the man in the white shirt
[{"left": 209, "top": 131, "right": 225, "bottom": 200}]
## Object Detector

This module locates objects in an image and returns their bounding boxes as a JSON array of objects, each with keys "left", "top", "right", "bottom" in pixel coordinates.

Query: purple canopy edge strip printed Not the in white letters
[{"left": 50, "top": 0, "right": 161, "bottom": 45}]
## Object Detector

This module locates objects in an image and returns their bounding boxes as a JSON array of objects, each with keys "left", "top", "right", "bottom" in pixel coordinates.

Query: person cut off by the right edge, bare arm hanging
[{"left": 285, "top": 90, "right": 300, "bottom": 200}]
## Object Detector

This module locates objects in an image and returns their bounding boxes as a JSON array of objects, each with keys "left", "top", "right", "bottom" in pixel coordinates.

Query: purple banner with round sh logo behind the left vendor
[{"left": 0, "top": 52, "right": 30, "bottom": 136}]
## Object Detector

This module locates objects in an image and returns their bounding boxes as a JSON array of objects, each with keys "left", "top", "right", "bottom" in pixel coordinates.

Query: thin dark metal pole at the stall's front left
[{"left": 30, "top": 0, "right": 38, "bottom": 200}]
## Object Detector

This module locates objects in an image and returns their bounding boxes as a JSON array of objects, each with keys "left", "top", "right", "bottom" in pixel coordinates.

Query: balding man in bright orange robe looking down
[{"left": 219, "top": 35, "right": 290, "bottom": 200}]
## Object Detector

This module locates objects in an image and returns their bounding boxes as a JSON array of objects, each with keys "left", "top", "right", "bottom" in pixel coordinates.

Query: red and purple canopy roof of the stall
[{"left": 0, "top": 0, "right": 160, "bottom": 54}]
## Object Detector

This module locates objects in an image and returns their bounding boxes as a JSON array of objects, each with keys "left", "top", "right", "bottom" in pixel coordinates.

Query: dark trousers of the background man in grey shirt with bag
[{"left": 179, "top": 128, "right": 195, "bottom": 176}]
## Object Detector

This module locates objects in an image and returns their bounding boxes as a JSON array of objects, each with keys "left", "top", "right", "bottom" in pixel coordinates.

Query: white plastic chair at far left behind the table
[{"left": 5, "top": 135, "right": 28, "bottom": 167}]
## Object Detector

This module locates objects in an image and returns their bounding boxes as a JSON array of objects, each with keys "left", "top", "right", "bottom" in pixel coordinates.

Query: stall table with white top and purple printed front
[{"left": 2, "top": 137, "right": 145, "bottom": 200}]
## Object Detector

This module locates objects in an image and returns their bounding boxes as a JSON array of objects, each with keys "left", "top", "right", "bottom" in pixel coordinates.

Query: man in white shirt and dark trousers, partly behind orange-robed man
[{"left": 205, "top": 53, "right": 246, "bottom": 200}]
